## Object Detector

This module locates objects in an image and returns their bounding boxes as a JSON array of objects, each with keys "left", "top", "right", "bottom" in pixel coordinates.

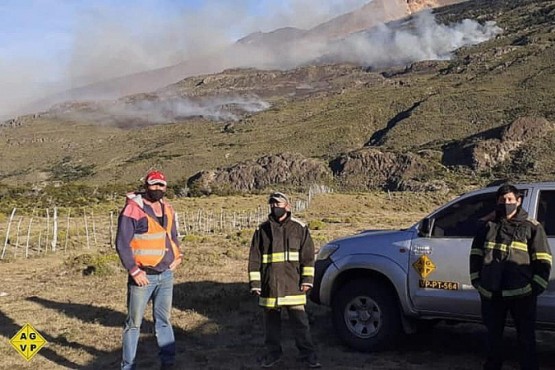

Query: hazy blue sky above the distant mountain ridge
[{"left": 0, "top": 0, "right": 370, "bottom": 118}]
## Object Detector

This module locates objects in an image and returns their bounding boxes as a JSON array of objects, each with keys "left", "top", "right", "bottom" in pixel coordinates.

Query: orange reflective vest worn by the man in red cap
[{"left": 130, "top": 202, "right": 180, "bottom": 267}]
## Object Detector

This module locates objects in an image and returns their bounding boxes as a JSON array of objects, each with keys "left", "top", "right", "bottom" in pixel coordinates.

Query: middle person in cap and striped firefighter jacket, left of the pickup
[{"left": 248, "top": 192, "right": 321, "bottom": 368}]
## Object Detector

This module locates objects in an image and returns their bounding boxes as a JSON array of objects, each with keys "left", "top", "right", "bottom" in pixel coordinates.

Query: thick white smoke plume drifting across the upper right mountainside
[{"left": 228, "top": 11, "right": 502, "bottom": 69}]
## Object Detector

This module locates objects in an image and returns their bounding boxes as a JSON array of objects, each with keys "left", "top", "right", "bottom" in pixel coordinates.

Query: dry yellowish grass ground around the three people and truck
[{"left": 0, "top": 193, "right": 555, "bottom": 370}]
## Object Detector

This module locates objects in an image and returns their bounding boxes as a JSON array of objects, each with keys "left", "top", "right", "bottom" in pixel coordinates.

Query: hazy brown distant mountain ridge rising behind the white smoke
[{"left": 24, "top": 0, "right": 470, "bottom": 112}]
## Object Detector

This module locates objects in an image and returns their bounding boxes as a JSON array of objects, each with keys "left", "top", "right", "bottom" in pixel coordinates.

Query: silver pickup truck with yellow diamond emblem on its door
[{"left": 310, "top": 182, "right": 555, "bottom": 351}]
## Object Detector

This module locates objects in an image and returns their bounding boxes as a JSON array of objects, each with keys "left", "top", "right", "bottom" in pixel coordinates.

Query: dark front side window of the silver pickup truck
[{"left": 432, "top": 192, "right": 496, "bottom": 238}]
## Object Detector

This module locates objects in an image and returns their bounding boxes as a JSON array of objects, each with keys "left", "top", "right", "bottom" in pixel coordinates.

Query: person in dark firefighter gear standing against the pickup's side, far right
[{"left": 470, "top": 184, "right": 552, "bottom": 370}]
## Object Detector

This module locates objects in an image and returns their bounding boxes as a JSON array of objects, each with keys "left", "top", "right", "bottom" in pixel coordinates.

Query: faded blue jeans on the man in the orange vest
[{"left": 121, "top": 270, "right": 175, "bottom": 370}]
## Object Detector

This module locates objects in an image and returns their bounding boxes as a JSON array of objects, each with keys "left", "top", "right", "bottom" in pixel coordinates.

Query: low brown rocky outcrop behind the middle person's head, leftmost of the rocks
[{"left": 187, "top": 153, "right": 331, "bottom": 195}]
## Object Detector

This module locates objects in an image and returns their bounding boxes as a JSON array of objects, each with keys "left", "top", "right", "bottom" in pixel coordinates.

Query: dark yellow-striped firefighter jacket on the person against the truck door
[{"left": 470, "top": 208, "right": 552, "bottom": 298}]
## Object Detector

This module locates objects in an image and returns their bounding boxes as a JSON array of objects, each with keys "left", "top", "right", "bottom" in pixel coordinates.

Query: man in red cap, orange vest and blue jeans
[{"left": 116, "top": 171, "right": 182, "bottom": 370}]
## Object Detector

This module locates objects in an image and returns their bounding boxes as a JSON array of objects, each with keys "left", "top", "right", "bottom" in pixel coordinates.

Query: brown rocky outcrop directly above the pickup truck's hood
[{"left": 330, "top": 148, "right": 443, "bottom": 191}]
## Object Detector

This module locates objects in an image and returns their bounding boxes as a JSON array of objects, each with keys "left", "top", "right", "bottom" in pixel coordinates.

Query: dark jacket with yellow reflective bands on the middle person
[{"left": 248, "top": 214, "right": 314, "bottom": 308}]
